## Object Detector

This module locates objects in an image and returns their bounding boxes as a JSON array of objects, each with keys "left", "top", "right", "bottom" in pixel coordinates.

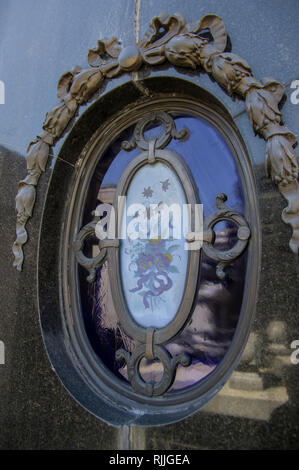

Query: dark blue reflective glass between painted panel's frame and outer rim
[{"left": 79, "top": 116, "right": 246, "bottom": 393}]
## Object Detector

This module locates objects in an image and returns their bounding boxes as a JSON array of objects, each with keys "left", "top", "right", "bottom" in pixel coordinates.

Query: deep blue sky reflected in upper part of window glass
[{"left": 102, "top": 117, "right": 244, "bottom": 216}]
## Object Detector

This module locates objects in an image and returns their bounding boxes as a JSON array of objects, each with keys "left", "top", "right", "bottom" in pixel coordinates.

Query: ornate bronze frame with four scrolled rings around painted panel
[{"left": 74, "top": 111, "right": 251, "bottom": 397}]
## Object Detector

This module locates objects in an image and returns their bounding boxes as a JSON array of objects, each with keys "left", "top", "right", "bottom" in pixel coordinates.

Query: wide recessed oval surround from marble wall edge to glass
[{"left": 38, "top": 77, "right": 261, "bottom": 426}]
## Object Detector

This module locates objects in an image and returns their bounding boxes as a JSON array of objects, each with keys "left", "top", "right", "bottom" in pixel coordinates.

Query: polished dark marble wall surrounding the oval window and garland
[{"left": 0, "top": 0, "right": 299, "bottom": 449}]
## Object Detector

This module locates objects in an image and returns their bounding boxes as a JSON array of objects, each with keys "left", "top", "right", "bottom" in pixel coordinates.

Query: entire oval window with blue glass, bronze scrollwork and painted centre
[{"left": 76, "top": 108, "right": 255, "bottom": 400}]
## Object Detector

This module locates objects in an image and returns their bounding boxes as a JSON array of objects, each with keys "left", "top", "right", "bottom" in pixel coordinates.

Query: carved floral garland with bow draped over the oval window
[{"left": 13, "top": 13, "right": 299, "bottom": 271}]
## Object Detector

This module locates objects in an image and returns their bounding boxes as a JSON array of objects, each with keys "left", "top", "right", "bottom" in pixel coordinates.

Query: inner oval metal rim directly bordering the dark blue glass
[{"left": 61, "top": 93, "right": 260, "bottom": 414}]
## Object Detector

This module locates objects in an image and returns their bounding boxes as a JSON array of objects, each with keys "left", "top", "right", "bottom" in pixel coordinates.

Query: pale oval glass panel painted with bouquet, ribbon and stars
[{"left": 120, "top": 162, "right": 188, "bottom": 328}]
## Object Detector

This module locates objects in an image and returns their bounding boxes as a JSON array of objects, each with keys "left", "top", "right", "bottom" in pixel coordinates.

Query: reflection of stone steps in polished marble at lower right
[{"left": 202, "top": 321, "right": 291, "bottom": 421}]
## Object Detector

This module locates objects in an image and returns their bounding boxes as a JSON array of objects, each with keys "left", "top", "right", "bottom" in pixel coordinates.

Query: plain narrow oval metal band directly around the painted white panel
[{"left": 108, "top": 150, "right": 201, "bottom": 344}]
